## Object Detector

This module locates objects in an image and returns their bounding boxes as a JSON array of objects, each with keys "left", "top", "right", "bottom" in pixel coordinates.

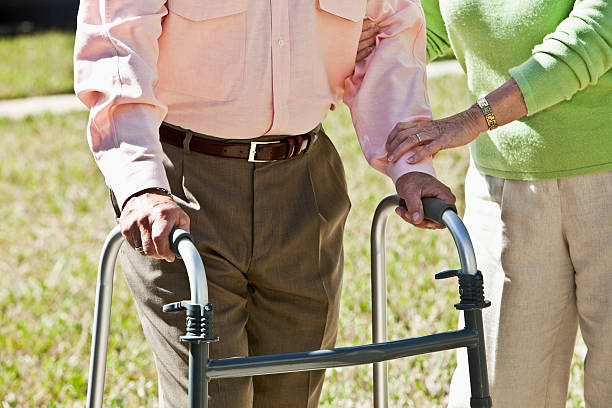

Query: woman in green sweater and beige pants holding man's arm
[{"left": 359, "top": 0, "right": 612, "bottom": 408}]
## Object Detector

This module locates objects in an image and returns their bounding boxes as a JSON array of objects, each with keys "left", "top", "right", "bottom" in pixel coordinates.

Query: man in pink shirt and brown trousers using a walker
[{"left": 75, "top": 0, "right": 454, "bottom": 407}]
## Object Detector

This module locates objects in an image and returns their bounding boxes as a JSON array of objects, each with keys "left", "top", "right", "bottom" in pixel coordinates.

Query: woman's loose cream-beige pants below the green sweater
[{"left": 449, "top": 166, "right": 612, "bottom": 408}]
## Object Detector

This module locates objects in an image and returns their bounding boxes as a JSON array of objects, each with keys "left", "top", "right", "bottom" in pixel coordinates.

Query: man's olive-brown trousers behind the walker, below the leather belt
[{"left": 122, "top": 126, "right": 350, "bottom": 408}]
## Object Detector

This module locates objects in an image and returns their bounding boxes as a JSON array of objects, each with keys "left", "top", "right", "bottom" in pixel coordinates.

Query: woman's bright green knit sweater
[{"left": 422, "top": 0, "right": 612, "bottom": 180}]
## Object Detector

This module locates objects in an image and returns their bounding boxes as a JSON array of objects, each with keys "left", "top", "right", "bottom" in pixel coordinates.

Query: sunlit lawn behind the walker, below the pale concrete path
[{"left": 0, "top": 78, "right": 583, "bottom": 408}]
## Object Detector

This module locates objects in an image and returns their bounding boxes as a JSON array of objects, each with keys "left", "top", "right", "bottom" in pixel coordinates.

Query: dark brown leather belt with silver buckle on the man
[{"left": 159, "top": 123, "right": 320, "bottom": 162}]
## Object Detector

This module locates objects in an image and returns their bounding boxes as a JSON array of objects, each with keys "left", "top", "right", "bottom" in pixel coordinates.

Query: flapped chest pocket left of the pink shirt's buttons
[{"left": 157, "top": 0, "right": 248, "bottom": 101}]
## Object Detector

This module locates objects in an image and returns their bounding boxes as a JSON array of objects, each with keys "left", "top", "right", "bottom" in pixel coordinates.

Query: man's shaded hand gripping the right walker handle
[{"left": 395, "top": 172, "right": 457, "bottom": 229}]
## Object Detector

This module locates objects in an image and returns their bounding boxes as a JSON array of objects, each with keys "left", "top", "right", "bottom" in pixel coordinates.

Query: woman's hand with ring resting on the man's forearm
[{"left": 386, "top": 105, "right": 487, "bottom": 163}]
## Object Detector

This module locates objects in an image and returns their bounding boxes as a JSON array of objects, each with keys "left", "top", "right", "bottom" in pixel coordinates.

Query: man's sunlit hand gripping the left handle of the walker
[{"left": 119, "top": 192, "right": 189, "bottom": 262}]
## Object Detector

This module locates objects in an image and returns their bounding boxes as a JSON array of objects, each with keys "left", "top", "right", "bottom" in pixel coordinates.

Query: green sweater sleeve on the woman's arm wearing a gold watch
[{"left": 510, "top": 0, "right": 612, "bottom": 115}]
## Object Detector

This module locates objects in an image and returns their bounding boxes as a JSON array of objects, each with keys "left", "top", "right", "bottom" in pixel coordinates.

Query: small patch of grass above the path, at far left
[{"left": 0, "top": 32, "right": 74, "bottom": 99}]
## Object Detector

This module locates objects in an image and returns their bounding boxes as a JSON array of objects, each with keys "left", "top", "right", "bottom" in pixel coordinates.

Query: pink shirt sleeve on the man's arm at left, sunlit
[{"left": 74, "top": 0, "right": 169, "bottom": 205}]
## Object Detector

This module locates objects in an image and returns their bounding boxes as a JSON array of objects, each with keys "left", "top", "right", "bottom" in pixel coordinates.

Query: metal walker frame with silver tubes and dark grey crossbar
[{"left": 87, "top": 195, "right": 492, "bottom": 408}]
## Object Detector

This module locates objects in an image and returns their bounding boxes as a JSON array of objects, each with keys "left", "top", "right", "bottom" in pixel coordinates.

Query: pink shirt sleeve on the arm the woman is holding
[{"left": 344, "top": 0, "right": 435, "bottom": 182}]
